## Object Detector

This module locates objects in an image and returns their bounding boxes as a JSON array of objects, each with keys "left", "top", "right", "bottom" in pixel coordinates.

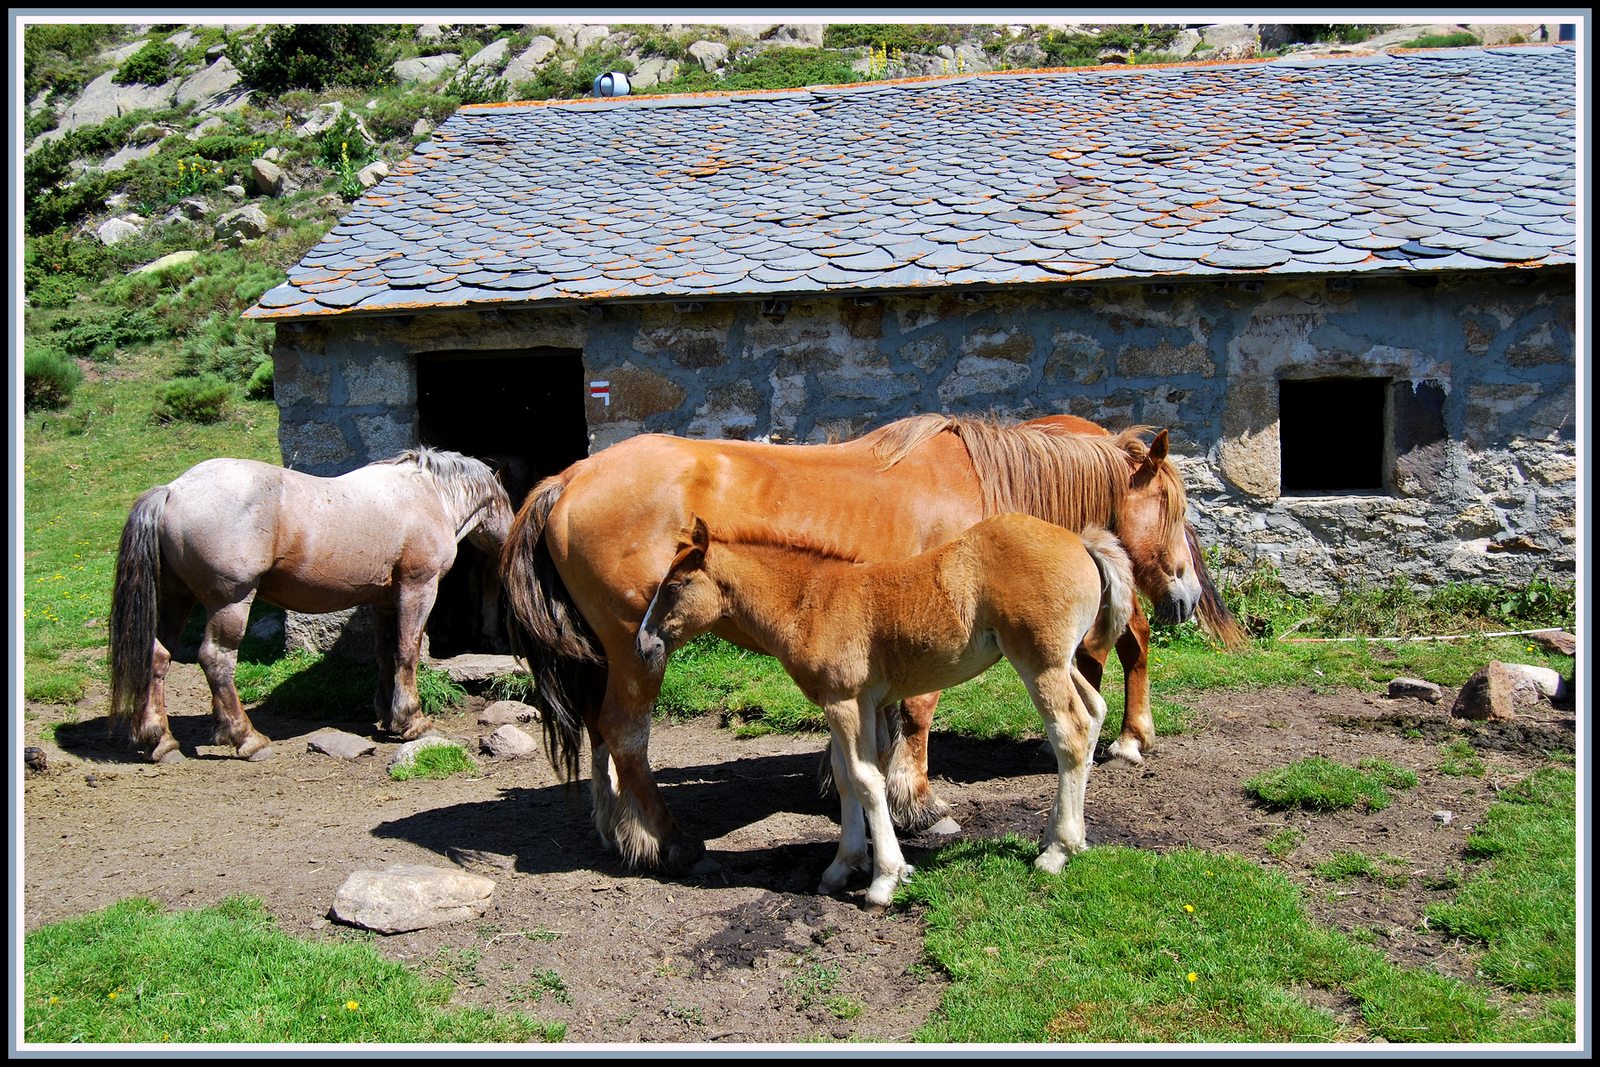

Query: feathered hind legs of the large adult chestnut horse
[{"left": 590, "top": 659, "right": 706, "bottom": 875}]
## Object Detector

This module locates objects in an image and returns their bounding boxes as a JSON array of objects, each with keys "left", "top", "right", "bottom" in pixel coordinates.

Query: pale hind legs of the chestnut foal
[{"left": 1022, "top": 662, "right": 1106, "bottom": 873}]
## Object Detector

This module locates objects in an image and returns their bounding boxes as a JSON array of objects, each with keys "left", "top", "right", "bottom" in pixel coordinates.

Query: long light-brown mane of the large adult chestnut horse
[{"left": 861, "top": 414, "right": 1184, "bottom": 536}]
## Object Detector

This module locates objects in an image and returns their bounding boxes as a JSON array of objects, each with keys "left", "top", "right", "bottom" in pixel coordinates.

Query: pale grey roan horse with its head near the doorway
[{"left": 110, "top": 448, "right": 512, "bottom": 763}]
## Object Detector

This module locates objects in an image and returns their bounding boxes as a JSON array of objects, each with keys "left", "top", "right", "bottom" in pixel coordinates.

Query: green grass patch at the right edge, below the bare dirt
[{"left": 1427, "top": 768, "right": 1578, "bottom": 992}]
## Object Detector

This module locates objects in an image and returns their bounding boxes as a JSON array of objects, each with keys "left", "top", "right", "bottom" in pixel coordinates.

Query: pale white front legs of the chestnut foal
[{"left": 818, "top": 697, "right": 912, "bottom": 912}]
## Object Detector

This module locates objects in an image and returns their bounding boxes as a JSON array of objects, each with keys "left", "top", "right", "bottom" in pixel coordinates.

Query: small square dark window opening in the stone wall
[{"left": 1278, "top": 378, "right": 1389, "bottom": 496}]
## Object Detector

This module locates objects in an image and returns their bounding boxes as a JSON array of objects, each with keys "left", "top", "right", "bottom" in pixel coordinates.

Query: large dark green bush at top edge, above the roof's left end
[{"left": 227, "top": 22, "right": 397, "bottom": 94}]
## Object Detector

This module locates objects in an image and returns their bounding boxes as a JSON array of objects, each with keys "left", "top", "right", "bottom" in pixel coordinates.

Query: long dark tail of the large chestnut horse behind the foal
[{"left": 501, "top": 475, "right": 606, "bottom": 782}]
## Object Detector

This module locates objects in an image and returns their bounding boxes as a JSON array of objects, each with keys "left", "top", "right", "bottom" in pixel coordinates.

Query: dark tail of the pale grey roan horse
[{"left": 110, "top": 485, "right": 168, "bottom": 735}]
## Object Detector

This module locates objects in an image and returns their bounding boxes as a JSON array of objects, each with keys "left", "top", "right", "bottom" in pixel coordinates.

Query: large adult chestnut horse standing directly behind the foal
[{"left": 501, "top": 414, "right": 1221, "bottom": 872}]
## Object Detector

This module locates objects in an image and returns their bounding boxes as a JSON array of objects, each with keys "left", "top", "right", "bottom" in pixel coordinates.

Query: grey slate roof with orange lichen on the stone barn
[{"left": 248, "top": 46, "right": 1578, "bottom": 318}]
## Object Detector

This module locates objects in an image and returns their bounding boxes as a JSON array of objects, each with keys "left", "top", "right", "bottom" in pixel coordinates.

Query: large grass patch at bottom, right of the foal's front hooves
[{"left": 901, "top": 837, "right": 1573, "bottom": 1043}]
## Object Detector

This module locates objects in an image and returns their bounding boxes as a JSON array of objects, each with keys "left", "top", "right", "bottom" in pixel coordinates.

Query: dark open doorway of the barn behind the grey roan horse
[{"left": 416, "top": 349, "right": 589, "bottom": 656}]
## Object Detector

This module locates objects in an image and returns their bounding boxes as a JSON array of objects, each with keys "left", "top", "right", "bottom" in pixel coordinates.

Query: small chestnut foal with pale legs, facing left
[{"left": 635, "top": 514, "right": 1134, "bottom": 910}]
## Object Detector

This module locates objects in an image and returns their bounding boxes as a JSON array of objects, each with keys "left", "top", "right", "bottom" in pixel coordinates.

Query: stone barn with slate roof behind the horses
[{"left": 250, "top": 45, "right": 1578, "bottom": 653}]
